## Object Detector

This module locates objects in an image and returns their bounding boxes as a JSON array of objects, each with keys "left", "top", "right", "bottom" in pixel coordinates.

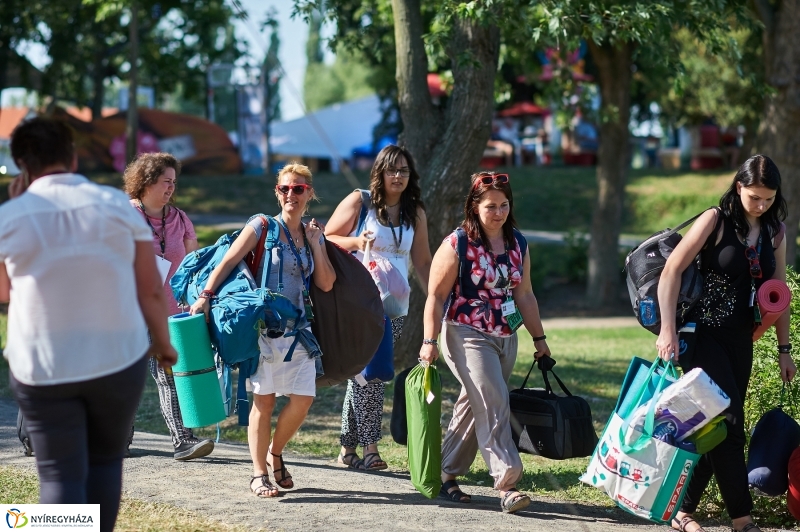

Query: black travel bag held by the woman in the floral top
[{"left": 509, "top": 357, "right": 597, "bottom": 460}]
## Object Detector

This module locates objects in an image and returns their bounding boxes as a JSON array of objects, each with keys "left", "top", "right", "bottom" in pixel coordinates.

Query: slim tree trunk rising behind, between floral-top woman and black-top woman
[{"left": 586, "top": 39, "right": 633, "bottom": 307}]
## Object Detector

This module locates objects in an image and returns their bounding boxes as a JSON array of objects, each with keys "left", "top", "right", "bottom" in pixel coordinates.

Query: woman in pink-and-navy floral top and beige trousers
[{"left": 419, "top": 172, "right": 550, "bottom": 513}]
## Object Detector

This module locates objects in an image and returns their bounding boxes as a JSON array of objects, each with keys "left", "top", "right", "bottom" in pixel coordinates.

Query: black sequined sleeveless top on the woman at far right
[{"left": 688, "top": 217, "right": 776, "bottom": 328}]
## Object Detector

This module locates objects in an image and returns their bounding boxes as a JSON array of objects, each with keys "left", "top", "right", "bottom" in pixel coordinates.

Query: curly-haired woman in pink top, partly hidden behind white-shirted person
[{"left": 122, "top": 153, "right": 214, "bottom": 460}]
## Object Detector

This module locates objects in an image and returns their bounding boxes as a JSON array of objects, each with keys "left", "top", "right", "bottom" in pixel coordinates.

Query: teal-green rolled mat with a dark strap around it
[{"left": 169, "top": 312, "right": 225, "bottom": 428}]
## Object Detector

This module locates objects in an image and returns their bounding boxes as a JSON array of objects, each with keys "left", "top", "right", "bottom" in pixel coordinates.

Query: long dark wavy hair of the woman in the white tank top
[{"left": 369, "top": 144, "right": 425, "bottom": 229}]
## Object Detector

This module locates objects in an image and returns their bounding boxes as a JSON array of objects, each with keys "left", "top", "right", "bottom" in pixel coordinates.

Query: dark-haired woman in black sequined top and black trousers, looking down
[{"left": 656, "top": 155, "right": 796, "bottom": 532}]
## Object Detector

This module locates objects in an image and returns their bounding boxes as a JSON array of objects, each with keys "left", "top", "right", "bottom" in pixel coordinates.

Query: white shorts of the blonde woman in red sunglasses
[{"left": 250, "top": 336, "right": 317, "bottom": 397}]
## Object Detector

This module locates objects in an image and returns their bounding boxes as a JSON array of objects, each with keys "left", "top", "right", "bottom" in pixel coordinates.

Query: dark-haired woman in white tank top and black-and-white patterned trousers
[{"left": 325, "top": 145, "right": 431, "bottom": 470}]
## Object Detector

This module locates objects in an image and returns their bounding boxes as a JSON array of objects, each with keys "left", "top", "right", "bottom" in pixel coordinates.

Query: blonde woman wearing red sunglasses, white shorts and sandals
[{"left": 190, "top": 163, "right": 336, "bottom": 497}]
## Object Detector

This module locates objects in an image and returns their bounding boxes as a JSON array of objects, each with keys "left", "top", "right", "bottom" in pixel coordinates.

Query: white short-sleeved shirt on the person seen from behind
[{"left": 0, "top": 174, "right": 153, "bottom": 385}]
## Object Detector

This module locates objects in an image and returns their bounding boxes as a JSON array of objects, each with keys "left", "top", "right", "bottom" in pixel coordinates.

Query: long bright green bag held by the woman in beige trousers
[{"left": 406, "top": 364, "right": 442, "bottom": 499}]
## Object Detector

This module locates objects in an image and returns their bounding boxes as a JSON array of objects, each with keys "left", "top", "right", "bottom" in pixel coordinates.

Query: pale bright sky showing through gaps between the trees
[{"left": 1, "top": 0, "right": 316, "bottom": 120}]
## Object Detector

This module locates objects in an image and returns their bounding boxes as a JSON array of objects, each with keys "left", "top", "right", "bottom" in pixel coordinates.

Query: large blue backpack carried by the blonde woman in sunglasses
[{"left": 170, "top": 214, "right": 307, "bottom": 426}]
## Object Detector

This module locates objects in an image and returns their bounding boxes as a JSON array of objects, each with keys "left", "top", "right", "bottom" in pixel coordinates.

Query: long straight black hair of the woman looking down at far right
[{"left": 719, "top": 155, "right": 787, "bottom": 238}]
